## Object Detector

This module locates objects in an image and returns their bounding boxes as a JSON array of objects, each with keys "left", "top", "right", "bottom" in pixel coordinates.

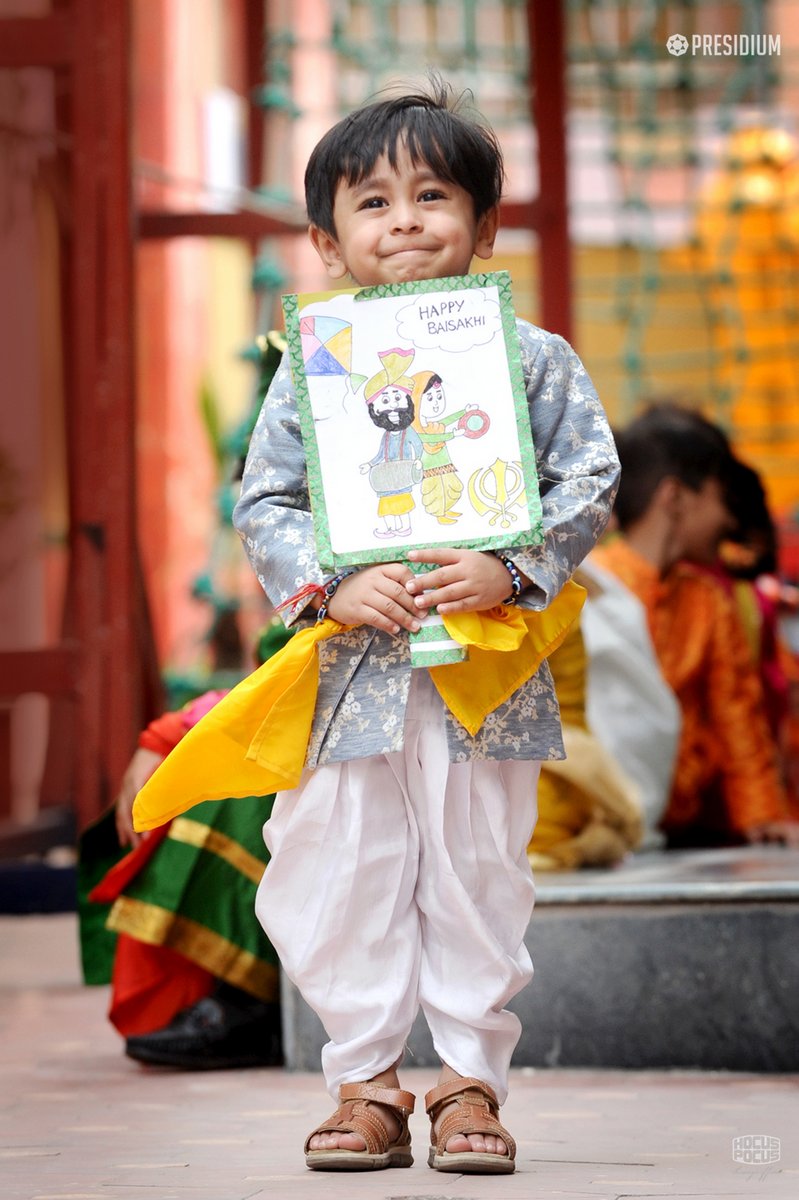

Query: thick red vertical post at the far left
[{"left": 70, "top": 0, "right": 142, "bottom": 823}]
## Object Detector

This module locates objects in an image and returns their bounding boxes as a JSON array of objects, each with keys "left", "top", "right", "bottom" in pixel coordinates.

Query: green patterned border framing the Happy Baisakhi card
[{"left": 282, "top": 271, "right": 543, "bottom": 571}]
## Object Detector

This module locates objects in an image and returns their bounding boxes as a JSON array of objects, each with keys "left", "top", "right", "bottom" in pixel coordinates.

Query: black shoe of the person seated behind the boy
[{"left": 125, "top": 988, "right": 283, "bottom": 1070}]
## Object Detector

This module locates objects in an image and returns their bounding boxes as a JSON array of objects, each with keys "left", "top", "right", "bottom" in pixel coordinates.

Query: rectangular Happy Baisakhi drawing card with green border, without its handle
[{"left": 283, "top": 271, "right": 541, "bottom": 570}]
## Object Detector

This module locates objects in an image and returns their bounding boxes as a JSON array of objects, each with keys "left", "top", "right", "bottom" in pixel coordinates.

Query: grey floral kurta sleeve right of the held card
[{"left": 506, "top": 322, "right": 620, "bottom": 608}]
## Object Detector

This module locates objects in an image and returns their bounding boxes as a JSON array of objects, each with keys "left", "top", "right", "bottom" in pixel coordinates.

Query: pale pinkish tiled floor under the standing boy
[{"left": 0, "top": 917, "right": 799, "bottom": 1200}]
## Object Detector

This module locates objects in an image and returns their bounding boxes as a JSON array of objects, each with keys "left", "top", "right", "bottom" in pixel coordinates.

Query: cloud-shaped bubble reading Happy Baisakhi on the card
[{"left": 397, "top": 288, "right": 501, "bottom": 354}]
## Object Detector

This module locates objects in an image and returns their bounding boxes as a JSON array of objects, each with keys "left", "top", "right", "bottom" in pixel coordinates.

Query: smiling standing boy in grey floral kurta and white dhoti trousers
[{"left": 234, "top": 82, "right": 618, "bottom": 1174}]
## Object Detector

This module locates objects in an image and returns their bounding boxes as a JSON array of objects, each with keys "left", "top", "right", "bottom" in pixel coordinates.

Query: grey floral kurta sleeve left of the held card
[{"left": 233, "top": 354, "right": 325, "bottom": 625}]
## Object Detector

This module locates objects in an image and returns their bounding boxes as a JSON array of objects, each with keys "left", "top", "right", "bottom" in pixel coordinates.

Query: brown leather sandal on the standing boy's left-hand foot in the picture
[{"left": 305, "top": 1082, "right": 416, "bottom": 1171}]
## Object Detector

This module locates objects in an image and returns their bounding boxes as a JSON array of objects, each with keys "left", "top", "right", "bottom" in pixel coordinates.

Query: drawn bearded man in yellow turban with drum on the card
[{"left": 361, "top": 349, "right": 422, "bottom": 538}]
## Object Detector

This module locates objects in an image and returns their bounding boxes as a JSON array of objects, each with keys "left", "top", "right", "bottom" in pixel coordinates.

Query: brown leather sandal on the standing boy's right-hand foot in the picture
[{"left": 425, "top": 1079, "right": 516, "bottom": 1175}]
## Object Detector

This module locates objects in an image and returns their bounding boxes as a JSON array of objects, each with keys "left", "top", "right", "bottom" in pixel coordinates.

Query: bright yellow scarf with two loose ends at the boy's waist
[{"left": 133, "top": 582, "right": 585, "bottom": 830}]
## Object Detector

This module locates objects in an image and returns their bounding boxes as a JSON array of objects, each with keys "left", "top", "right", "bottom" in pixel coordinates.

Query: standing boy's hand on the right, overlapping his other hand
[{"left": 405, "top": 547, "right": 529, "bottom": 616}]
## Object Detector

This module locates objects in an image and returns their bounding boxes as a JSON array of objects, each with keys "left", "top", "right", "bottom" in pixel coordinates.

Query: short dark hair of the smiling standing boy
[{"left": 305, "top": 73, "right": 505, "bottom": 238}]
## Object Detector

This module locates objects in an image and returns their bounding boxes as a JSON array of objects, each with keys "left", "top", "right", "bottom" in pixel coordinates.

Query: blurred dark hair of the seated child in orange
[{"left": 613, "top": 403, "right": 734, "bottom": 529}]
